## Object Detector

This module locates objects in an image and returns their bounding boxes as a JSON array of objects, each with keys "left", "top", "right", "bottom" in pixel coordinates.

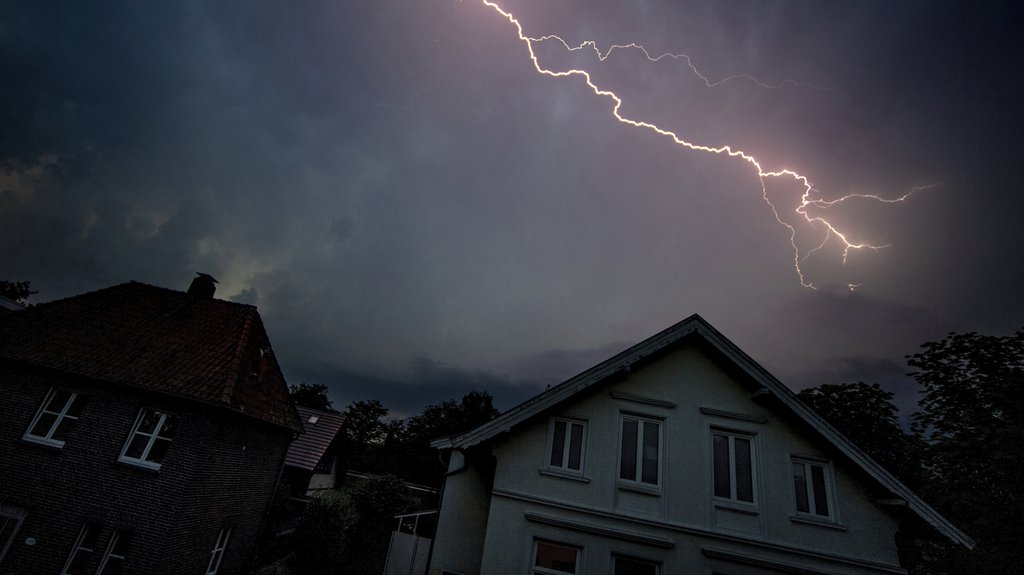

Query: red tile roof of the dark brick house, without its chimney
[{"left": 0, "top": 281, "right": 301, "bottom": 431}]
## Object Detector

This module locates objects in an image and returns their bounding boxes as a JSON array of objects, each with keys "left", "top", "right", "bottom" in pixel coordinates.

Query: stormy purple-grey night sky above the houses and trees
[{"left": 0, "top": 0, "right": 1024, "bottom": 416}]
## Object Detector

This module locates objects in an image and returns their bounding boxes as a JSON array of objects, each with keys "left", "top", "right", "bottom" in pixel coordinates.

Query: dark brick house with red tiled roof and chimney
[{"left": 0, "top": 274, "right": 302, "bottom": 574}]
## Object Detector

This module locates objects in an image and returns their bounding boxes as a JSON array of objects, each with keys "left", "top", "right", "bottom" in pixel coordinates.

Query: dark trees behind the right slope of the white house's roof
[{"left": 798, "top": 331, "right": 1024, "bottom": 575}]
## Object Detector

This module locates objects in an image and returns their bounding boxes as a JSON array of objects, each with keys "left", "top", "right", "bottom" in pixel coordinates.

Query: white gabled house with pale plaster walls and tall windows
[{"left": 428, "top": 315, "right": 973, "bottom": 575}]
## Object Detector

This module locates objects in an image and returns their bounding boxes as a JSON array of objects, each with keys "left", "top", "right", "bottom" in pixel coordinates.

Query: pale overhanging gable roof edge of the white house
[{"left": 431, "top": 314, "right": 974, "bottom": 548}]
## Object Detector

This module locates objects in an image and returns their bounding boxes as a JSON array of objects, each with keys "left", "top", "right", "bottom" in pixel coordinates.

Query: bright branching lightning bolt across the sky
[{"left": 471, "top": 0, "right": 939, "bottom": 292}]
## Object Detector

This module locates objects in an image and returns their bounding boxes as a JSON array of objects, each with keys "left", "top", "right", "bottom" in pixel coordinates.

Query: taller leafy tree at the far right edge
[{"left": 908, "top": 331, "right": 1024, "bottom": 574}]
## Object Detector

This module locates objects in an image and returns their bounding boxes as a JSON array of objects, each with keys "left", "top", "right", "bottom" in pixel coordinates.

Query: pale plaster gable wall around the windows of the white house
[{"left": 483, "top": 341, "right": 898, "bottom": 574}]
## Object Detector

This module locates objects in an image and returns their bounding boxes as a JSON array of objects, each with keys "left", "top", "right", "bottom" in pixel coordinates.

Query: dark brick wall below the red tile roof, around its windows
[{"left": 0, "top": 364, "right": 291, "bottom": 574}]
